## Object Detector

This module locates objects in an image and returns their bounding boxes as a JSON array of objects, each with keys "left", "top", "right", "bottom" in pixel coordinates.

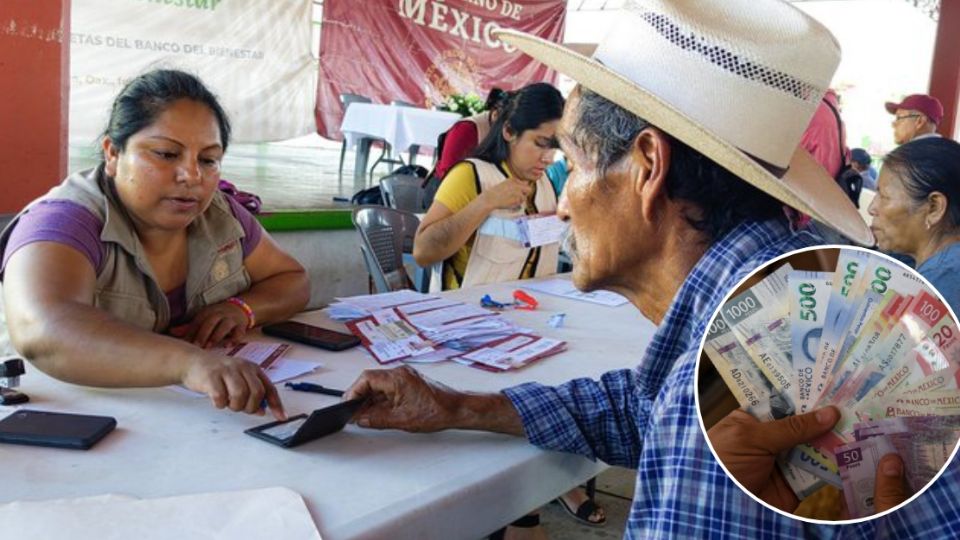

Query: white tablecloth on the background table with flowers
[{"left": 340, "top": 103, "right": 461, "bottom": 152}]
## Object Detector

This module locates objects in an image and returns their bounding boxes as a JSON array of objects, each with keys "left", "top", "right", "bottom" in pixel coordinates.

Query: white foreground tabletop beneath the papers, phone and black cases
[{"left": 0, "top": 276, "right": 654, "bottom": 540}]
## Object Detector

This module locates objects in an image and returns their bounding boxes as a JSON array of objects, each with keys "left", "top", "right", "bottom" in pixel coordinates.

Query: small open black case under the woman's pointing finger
[{"left": 244, "top": 399, "right": 363, "bottom": 448}]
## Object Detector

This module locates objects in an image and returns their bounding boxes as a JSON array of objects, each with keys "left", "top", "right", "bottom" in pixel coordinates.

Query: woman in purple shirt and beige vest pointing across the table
[{"left": 0, "top": 70, "right": 309, "bottom": 418}]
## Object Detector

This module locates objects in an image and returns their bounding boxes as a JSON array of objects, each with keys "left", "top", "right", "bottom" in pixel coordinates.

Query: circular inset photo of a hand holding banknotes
[{"left": 696, "top": 246, "right": 960, "bottom": 524}]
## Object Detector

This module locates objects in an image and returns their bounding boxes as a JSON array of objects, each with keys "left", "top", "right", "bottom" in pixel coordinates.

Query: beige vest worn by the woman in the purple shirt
[{"left": 0, "top": 167, "right": 250, "bottom": 332}]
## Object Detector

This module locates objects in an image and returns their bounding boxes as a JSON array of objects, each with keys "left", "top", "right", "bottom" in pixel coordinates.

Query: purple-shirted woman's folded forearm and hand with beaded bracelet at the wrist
[{"left": 178, "top": 232, "right": 310, "bottom": 347}]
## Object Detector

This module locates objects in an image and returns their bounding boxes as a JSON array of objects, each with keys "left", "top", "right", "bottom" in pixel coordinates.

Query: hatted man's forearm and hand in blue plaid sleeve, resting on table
[{"left": 344, "top": 366, "right": 650, "bottom": 467}]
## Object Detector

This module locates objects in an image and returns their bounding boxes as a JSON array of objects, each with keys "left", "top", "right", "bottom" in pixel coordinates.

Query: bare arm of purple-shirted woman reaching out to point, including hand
[{"left": 3, "top": 242, "right": 284, "bottom": 417}]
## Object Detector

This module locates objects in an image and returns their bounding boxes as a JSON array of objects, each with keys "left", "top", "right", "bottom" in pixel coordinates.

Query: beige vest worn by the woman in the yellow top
[{"left": 460, "top": 158, "right": 560, "bottom": 288}]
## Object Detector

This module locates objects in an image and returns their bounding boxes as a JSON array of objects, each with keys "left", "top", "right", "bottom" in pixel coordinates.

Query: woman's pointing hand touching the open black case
[{"left": 181, "top": 351, "right": 287, "bottom": 420}]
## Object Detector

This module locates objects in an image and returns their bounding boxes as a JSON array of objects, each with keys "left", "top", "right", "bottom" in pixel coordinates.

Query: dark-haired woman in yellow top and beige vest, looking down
[{"left": 413, "top": 83, "right": 563, "bottom": 289}]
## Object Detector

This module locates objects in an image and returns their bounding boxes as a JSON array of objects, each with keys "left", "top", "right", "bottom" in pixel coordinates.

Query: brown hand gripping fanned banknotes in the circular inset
[{"left": 707, "top": 407, "right": 907, "bottom": 512}]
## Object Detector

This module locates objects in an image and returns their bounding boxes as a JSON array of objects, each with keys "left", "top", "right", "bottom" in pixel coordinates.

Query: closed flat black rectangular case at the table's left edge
[{"left": 0, "top": 409, "right": 117, "bottom": 450}]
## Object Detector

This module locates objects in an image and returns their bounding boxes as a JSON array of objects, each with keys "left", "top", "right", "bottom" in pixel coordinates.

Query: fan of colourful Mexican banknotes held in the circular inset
[{"left": 704, "top": 250, "right": 960, "bottom": 517}]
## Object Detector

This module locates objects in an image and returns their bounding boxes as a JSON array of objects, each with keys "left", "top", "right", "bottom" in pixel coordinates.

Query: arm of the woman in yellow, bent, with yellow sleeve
[{"left": 413, "top": 164, "right": 533, "bottom": 266}]
